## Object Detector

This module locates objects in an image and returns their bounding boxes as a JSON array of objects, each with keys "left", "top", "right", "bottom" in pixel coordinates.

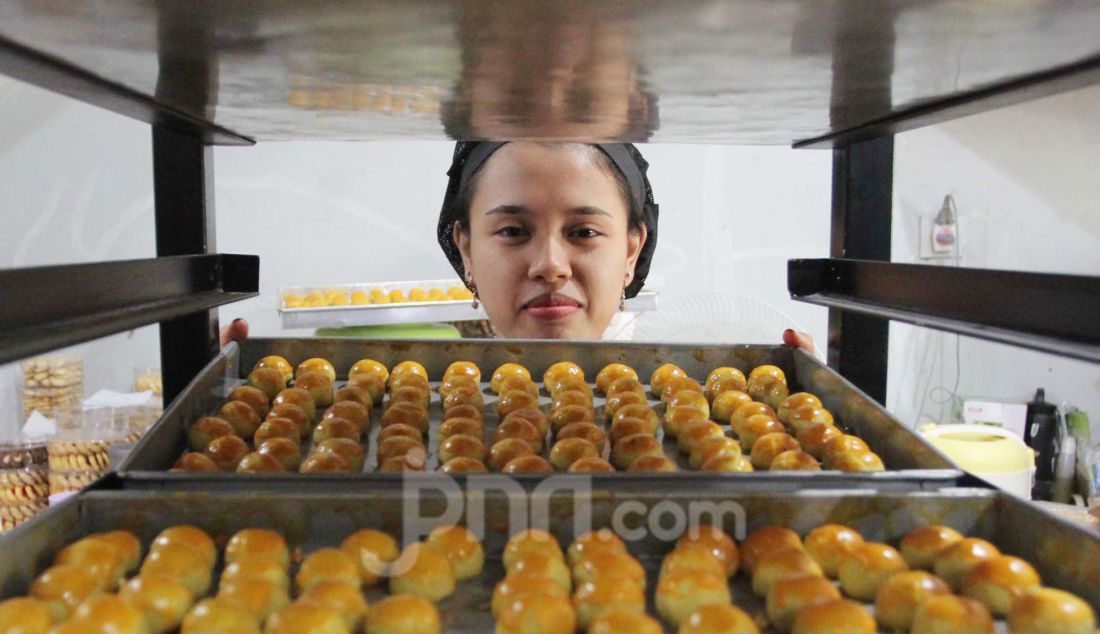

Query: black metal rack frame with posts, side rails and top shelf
[{"left": 0, "top": 0, "right": 1100, "bottom": 402}]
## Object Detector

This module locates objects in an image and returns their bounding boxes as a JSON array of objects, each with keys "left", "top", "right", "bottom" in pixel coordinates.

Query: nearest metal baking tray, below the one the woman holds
[{"left": 0, "top": 482, "right": 1100, "bottom": 632}]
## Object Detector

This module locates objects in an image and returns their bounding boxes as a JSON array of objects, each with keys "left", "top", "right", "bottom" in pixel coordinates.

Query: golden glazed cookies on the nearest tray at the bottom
[{"left": 8, "top": 524, "right": 1096, "bottom": 634}]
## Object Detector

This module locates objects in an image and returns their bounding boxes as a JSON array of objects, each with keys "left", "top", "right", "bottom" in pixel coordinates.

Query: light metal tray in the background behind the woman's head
[{"left": 278, "top": 278, "right": 657, "bottom": 328}]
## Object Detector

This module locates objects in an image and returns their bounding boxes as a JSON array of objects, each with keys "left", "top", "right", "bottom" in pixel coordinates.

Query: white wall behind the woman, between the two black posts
[{"left": 215, "top": 142, "right": 831, "bottom": 342}]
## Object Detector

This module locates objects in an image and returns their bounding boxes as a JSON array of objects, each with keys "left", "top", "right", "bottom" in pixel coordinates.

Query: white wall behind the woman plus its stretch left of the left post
[{"left": 0, "top": 77, "right": 829, "bottom": 436}]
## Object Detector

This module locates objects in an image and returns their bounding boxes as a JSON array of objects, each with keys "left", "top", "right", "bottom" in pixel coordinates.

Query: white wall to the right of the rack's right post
[{"left": 887, "top": 87, "right": 1100, "bottom": 423}]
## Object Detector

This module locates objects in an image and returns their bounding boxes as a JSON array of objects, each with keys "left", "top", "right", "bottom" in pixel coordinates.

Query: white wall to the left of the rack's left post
[{"left": 0, "top": 77, "right": 160, "bottom": 438}]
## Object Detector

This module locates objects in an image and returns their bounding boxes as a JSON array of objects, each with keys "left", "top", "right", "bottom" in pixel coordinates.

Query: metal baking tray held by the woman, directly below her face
[{"left": 119, "top": 339, "right": 965, "bottom": 491}]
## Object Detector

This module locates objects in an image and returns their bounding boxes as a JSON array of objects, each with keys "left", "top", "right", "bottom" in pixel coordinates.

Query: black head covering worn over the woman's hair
[{"left": 437, "top": 141, "right": 659, "bottom": 297}]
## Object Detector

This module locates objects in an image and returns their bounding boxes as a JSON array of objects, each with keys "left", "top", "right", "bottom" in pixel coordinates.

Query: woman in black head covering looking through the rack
[{"left": 222, "top": 142, "right": 813, "bottom": 351}]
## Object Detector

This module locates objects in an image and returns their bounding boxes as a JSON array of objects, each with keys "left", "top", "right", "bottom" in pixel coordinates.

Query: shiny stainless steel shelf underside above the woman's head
[{"left": 0, "top": 0, "right": 1100, "bottom": 146}]
